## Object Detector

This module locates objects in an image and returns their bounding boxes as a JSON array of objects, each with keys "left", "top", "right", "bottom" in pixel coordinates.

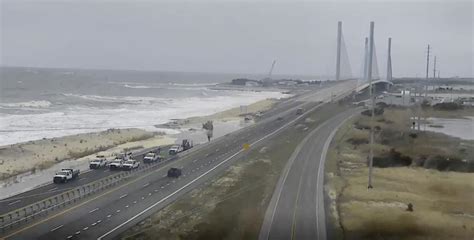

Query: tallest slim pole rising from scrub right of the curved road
[{"left": 367, "top": 22, "right": 375, "bottom": 189}]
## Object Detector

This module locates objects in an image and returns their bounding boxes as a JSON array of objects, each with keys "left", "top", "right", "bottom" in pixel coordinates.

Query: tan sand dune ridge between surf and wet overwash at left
[{"left": 0, "top": 129, "right": 165, "bottom": 179}]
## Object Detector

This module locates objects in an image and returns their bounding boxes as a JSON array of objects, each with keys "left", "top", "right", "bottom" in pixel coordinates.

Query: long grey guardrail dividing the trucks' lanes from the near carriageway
[{"left": 0, "top": 148, "right": 178, "bottom": 233}]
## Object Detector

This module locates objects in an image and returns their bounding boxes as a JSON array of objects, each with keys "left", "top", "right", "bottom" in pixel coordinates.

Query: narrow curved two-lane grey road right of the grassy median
[{"left": 259, "top": 109, "right": 358, "bottom": 240}]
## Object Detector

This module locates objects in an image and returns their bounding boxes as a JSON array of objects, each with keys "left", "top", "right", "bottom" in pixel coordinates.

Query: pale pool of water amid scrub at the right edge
[{"left": 424, "top": 117, "right": 474, "bottom": 140}]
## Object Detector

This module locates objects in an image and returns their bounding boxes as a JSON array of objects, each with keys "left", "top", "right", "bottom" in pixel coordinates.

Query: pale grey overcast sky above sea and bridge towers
[{"left": 0, "top": 0, "right": 474, "bottom": 77}]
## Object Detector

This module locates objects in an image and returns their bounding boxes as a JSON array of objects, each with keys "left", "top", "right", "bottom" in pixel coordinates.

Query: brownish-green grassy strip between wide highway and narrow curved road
[{"left": 121, "top": 104, "right": 347, "bottom": 240}]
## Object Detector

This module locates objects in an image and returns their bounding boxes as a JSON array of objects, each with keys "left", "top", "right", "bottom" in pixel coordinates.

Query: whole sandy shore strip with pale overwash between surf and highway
[{"left": 0, "top": 96, "right": 281, "bottom": 198}]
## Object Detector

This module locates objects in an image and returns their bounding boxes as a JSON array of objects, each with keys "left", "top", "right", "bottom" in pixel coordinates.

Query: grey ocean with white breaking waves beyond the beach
[{"left": 0, "top": 67, "right": 287, "bottom": 146}]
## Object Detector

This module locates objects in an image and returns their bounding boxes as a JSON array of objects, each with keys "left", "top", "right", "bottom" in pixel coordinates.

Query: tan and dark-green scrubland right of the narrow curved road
[{"left": 325, "top": 108, "right": 474, "bottom": 239}]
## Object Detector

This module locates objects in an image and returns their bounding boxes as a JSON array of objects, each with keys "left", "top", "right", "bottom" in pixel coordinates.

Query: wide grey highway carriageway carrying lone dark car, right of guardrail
[{"left": 1, "top": 80, "right": 356, "bottom": 239}]
